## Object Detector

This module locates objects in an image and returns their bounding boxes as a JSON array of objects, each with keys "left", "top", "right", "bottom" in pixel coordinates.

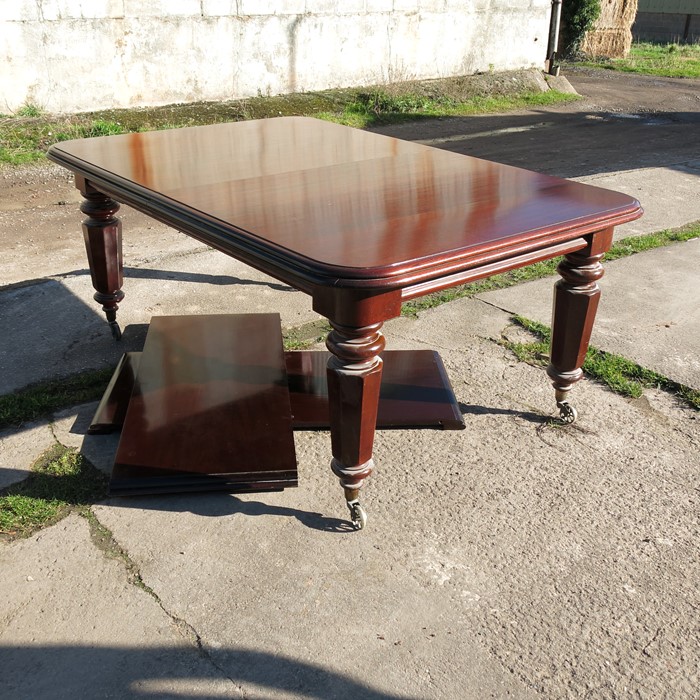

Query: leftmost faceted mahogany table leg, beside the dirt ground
[{"left": 78, "top": 181, "right": 124, "bottom": 340}]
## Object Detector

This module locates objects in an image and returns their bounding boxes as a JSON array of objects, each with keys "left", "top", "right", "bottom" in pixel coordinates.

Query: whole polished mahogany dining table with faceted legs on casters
[{"left": 48, "top": 117, "right": 642, "bottom": 529}]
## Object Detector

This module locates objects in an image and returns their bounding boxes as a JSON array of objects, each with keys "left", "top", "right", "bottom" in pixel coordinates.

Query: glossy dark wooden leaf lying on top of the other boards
[{"left": 110, "top": 314, "right": 297, "bottom": 494}]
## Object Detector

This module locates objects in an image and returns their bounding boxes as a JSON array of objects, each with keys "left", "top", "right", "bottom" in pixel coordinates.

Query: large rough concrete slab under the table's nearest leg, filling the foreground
[{"left": 80, "top": 300, "right": 700, "bottom": 699}]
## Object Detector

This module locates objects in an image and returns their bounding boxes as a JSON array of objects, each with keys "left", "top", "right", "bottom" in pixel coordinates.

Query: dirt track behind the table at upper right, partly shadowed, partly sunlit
[{"left": 380, "top": 70, "right": 700, "bottom": 178}]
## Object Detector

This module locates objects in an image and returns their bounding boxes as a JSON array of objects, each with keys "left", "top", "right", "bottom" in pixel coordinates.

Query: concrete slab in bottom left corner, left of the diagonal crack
[{"left": 0, "top": 515, "right": 238, "bottom": 700}]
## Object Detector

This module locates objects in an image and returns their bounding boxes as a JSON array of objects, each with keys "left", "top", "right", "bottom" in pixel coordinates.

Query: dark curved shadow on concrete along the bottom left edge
[{"left": 0, "top": 645, "right": 408, "bottom": 700}]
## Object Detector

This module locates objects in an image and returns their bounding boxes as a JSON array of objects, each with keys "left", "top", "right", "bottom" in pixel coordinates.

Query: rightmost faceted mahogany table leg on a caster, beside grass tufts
[{"left": 547, "top": 229, "right": 612, "bottom": 423}]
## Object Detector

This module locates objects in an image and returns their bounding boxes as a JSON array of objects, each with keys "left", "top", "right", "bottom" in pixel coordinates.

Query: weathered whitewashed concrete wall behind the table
[{"left": 0, "top": 0, "right": 550, "bottom": 112}]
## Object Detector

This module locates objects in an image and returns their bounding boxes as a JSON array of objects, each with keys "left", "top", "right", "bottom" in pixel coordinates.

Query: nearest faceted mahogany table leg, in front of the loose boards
[{"left": 326, "top": 323, "right": 384, "bottom": 530}]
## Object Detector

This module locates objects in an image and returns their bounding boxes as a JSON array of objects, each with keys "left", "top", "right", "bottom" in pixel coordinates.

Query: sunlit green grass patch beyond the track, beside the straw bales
[{"left": 576, "top": 42, "right": 700, "bottom": 78}]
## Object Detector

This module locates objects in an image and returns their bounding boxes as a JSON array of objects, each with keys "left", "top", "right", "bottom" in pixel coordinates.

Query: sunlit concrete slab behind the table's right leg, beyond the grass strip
[{"left": 479, "top": 239, "right": 700, "bottom": 389}]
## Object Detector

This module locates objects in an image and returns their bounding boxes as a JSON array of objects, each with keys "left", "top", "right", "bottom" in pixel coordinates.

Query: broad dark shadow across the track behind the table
[{"left": 372, "top": 110, "right": 700, "bottom": 178}]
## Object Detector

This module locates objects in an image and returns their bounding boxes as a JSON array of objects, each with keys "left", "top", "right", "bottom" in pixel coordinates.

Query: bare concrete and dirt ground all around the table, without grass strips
[{"left": 0, "top": 72, "right": 700, "bottom": 700}]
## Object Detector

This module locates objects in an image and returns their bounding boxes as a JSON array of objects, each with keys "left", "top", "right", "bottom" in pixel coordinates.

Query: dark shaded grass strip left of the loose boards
[{"left": 0, "top": 368, "right": 114, "bottom": 429}]
